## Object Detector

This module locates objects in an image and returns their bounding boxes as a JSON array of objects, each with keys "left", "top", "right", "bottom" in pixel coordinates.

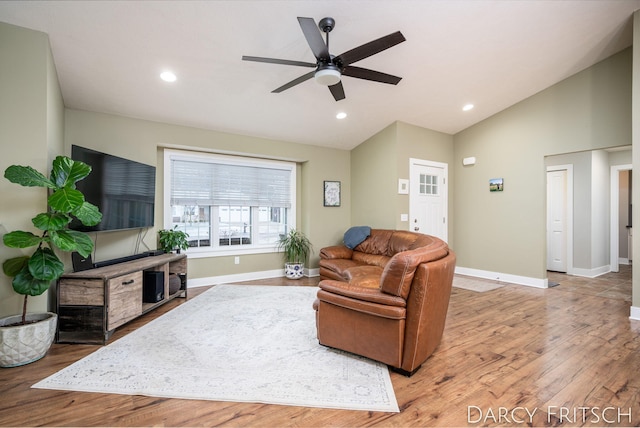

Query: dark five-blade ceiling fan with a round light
[{"left": 242, "top": 17, "right": 406, "bottom": 101}]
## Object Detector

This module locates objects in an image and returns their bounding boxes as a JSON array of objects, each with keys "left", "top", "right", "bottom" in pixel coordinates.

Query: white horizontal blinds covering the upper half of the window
[{"left": 171, "top": 159, "right": 292, "bottom": 208}]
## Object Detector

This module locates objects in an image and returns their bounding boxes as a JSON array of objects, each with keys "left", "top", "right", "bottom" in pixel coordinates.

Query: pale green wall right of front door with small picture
[{"left": 453, "top": 49, "right": 631, "bottom": 279}]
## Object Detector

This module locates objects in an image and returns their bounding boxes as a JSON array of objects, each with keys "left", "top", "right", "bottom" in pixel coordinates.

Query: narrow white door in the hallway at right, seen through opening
[{"left": 547, "top": 169, "right": 567, "bottom": 272}]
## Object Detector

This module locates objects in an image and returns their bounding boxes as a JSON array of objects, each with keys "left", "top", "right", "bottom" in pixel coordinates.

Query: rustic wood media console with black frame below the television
[{"left": 57, "top": 254, "right": 187, "bottom": 344}]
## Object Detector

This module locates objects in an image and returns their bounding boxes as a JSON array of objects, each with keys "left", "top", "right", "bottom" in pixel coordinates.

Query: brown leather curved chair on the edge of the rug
[{"left": 314, "top": 230, "right": 456, "bottom": 376}]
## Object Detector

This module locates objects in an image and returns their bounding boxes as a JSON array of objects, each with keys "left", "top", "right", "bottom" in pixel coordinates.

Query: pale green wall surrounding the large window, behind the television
[{"left": 65, "top": 109, "right": 351, "bottom": 279}]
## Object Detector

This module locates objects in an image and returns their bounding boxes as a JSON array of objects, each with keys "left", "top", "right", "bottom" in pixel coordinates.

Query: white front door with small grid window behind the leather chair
[{"left": 409, "top": 159, "right": 448, "bottom": 242}]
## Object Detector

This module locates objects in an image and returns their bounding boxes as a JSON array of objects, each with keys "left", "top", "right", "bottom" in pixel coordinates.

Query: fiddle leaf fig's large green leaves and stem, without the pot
[{"left": 2, "top": 156, "right": 102, "bottom": 324}]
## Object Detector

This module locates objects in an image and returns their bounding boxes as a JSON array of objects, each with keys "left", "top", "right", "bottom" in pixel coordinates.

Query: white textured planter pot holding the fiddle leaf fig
[{"left": 0, "top": 312, "right": 58, "bottom": 367}]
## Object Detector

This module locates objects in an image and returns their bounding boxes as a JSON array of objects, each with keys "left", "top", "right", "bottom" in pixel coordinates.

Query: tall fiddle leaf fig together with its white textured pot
[{"left": 0, "top": 156, "right": 102, "bottom": 367}]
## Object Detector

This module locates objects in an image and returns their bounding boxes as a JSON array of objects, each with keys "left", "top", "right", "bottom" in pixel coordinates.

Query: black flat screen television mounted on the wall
[{"left": 69, "top": 145, "right": 156, "bottom": 232}]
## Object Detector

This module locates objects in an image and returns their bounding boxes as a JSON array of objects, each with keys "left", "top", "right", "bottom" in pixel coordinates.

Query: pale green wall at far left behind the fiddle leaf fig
[{"left": 0, "top": 23, "right": 64, "bottom": 316}]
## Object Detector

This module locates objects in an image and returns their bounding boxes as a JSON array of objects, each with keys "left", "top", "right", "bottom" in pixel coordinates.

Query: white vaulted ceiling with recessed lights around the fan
[{"left": 0, "top": 0, "right": 640, "bottom": 149}]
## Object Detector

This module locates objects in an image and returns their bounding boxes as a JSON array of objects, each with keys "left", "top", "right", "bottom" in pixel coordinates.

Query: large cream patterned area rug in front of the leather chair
[{"left": 33, "top": 285, "right": 399, "bottom": 412}]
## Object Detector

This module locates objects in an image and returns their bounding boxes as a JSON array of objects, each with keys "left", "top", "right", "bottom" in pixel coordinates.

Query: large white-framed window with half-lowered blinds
[{"left": 164, "top": 150, "right": 296, "bottom": 257}]
